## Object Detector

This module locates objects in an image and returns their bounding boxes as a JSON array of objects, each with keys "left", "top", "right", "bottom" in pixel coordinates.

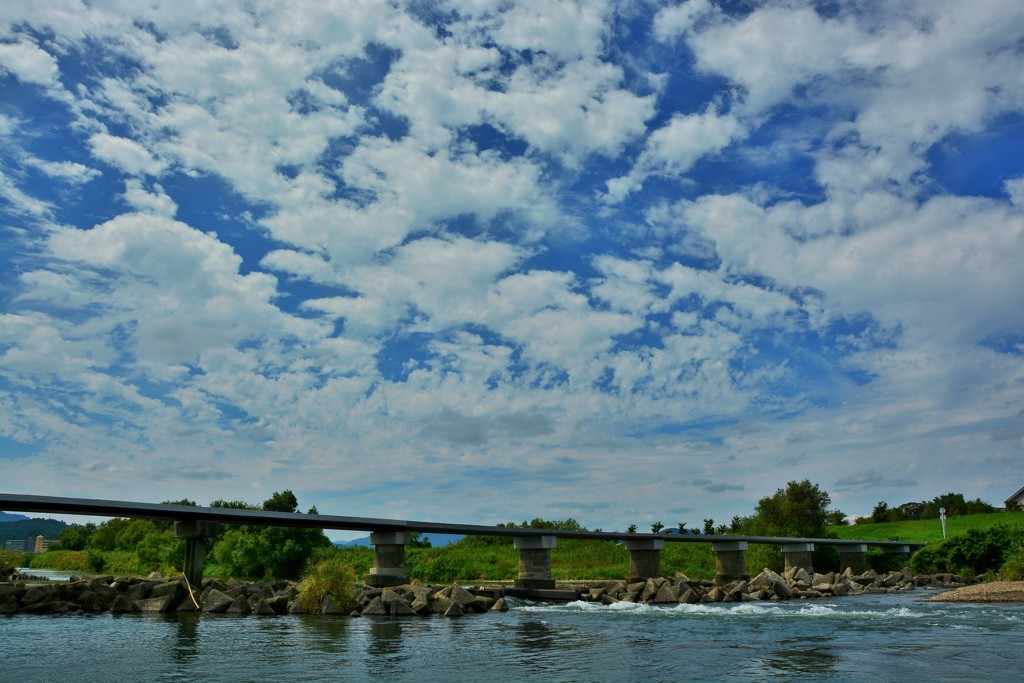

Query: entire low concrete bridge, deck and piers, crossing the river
[{"left": 0, "top": 494, "right": 924, "bottom": 589}]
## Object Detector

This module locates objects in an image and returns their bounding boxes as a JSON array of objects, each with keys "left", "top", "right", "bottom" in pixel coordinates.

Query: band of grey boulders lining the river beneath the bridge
[{"left": 0, "top": 569, "right": 974, "bottom": 616}]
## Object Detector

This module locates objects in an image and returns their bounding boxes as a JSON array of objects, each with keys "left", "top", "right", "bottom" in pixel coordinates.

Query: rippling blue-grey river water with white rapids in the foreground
[{"left": 0, "top": 591, "right": 1024, "bottom": 683}]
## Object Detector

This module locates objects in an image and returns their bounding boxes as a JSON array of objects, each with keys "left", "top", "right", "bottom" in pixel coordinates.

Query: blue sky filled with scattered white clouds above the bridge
[{"left": 0, "top": 0, "right": 1024, "bottom": 539}]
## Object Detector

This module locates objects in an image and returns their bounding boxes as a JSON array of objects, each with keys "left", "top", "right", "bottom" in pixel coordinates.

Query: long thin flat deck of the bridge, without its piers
[{"left": 0, "top": 494, "right": 924, "bottom": 548}]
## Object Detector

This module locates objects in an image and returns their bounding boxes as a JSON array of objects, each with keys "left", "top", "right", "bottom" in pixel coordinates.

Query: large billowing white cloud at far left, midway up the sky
[{"left": 49, "top": 214, "right": 318, "bottom": 364}]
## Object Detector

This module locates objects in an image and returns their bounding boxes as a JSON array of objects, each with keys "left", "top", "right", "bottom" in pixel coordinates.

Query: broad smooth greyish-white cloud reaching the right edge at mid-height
[{"left": 687, "top": 191, "right": 1024, "bottom": 344}]
